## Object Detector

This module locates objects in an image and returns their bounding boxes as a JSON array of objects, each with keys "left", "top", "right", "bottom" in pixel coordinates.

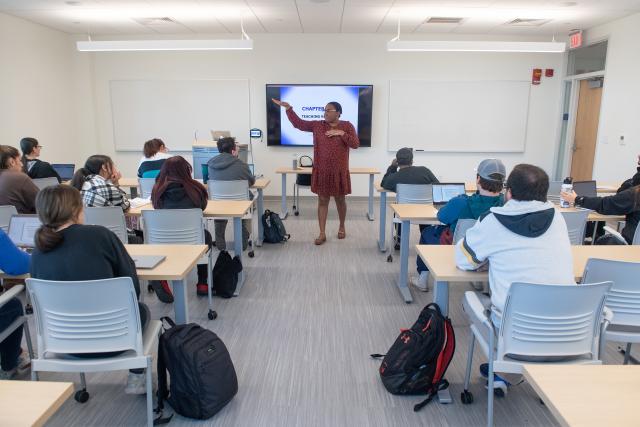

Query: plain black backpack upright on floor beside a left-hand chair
[{"left": 154, "top": 317, "right": 238, "bottom": 425}]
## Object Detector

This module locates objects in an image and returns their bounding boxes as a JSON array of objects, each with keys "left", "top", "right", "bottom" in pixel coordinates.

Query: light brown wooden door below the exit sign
[{"left": 571, "top": 80, "right": 602, "bottom": 181}]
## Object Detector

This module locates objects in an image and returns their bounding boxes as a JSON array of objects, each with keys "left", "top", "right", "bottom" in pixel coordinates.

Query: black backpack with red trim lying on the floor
[{"left": 371, "top": 303, "right": 456, "bottom": 411}]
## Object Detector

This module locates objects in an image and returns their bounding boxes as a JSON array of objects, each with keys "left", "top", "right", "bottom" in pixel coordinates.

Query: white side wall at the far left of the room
[{"left": 0, "top": 14, "right": 96, "bottom": 163}]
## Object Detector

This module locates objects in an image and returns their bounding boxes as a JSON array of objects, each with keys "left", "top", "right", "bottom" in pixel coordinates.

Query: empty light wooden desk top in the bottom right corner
[{"left": 523, "top": 364, "right": 640, "bottom": 427}]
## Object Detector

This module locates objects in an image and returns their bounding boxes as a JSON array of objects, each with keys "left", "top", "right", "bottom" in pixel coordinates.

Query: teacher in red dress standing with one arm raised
[{"left": 272, "top": 99, "right": 360, "bottom": 245}]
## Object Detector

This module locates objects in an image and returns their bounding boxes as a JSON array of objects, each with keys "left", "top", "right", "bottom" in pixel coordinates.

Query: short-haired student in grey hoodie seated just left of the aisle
[{"left": 207, "top": 137, "right": 256, "bottom": 250}]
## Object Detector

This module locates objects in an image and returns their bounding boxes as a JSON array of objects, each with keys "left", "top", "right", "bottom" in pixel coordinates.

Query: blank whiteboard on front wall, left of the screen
[{"left": 109, "top": 79, "right": 251, "bottom": 152}]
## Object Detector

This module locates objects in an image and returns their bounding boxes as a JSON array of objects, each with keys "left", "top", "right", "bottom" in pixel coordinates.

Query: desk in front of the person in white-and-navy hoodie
[{"left": 418, "top": 244, "right": 640, "bottom": 318}]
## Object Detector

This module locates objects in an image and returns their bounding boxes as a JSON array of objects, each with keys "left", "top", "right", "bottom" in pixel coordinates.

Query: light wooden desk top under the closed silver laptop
[{"left": 125, "top": 245, "right": 207, "bottom": 280}]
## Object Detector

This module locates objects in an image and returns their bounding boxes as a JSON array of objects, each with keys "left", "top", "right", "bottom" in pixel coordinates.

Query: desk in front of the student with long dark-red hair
[{"left": 125, "top": 200, "right": 254, "bottom": 296}]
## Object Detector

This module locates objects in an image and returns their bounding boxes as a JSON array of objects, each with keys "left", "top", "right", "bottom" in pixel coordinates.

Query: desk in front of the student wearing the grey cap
[{"left": 391, "top": 203, "right": 620, "bottom": 303}]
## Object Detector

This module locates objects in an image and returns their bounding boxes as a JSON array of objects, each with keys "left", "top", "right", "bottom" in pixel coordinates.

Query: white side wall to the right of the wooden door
[{"left": 586, "top": 14, "right": 640, "bottom": 181}]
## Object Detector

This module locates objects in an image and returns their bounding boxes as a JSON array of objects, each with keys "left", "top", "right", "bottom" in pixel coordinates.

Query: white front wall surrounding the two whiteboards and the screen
[{"left": 83, "top": 34, "right": 563, "bottom": 196}]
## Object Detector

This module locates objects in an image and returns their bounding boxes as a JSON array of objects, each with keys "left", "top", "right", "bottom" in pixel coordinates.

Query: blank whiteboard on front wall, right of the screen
[{"left": 388, "top": 80, "right": 531, "bottom": 152}]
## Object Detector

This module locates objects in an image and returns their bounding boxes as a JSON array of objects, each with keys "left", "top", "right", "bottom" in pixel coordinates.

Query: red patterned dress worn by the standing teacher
[{"left": 287, "top": 108, "right": 360, "bottom": 196}]
